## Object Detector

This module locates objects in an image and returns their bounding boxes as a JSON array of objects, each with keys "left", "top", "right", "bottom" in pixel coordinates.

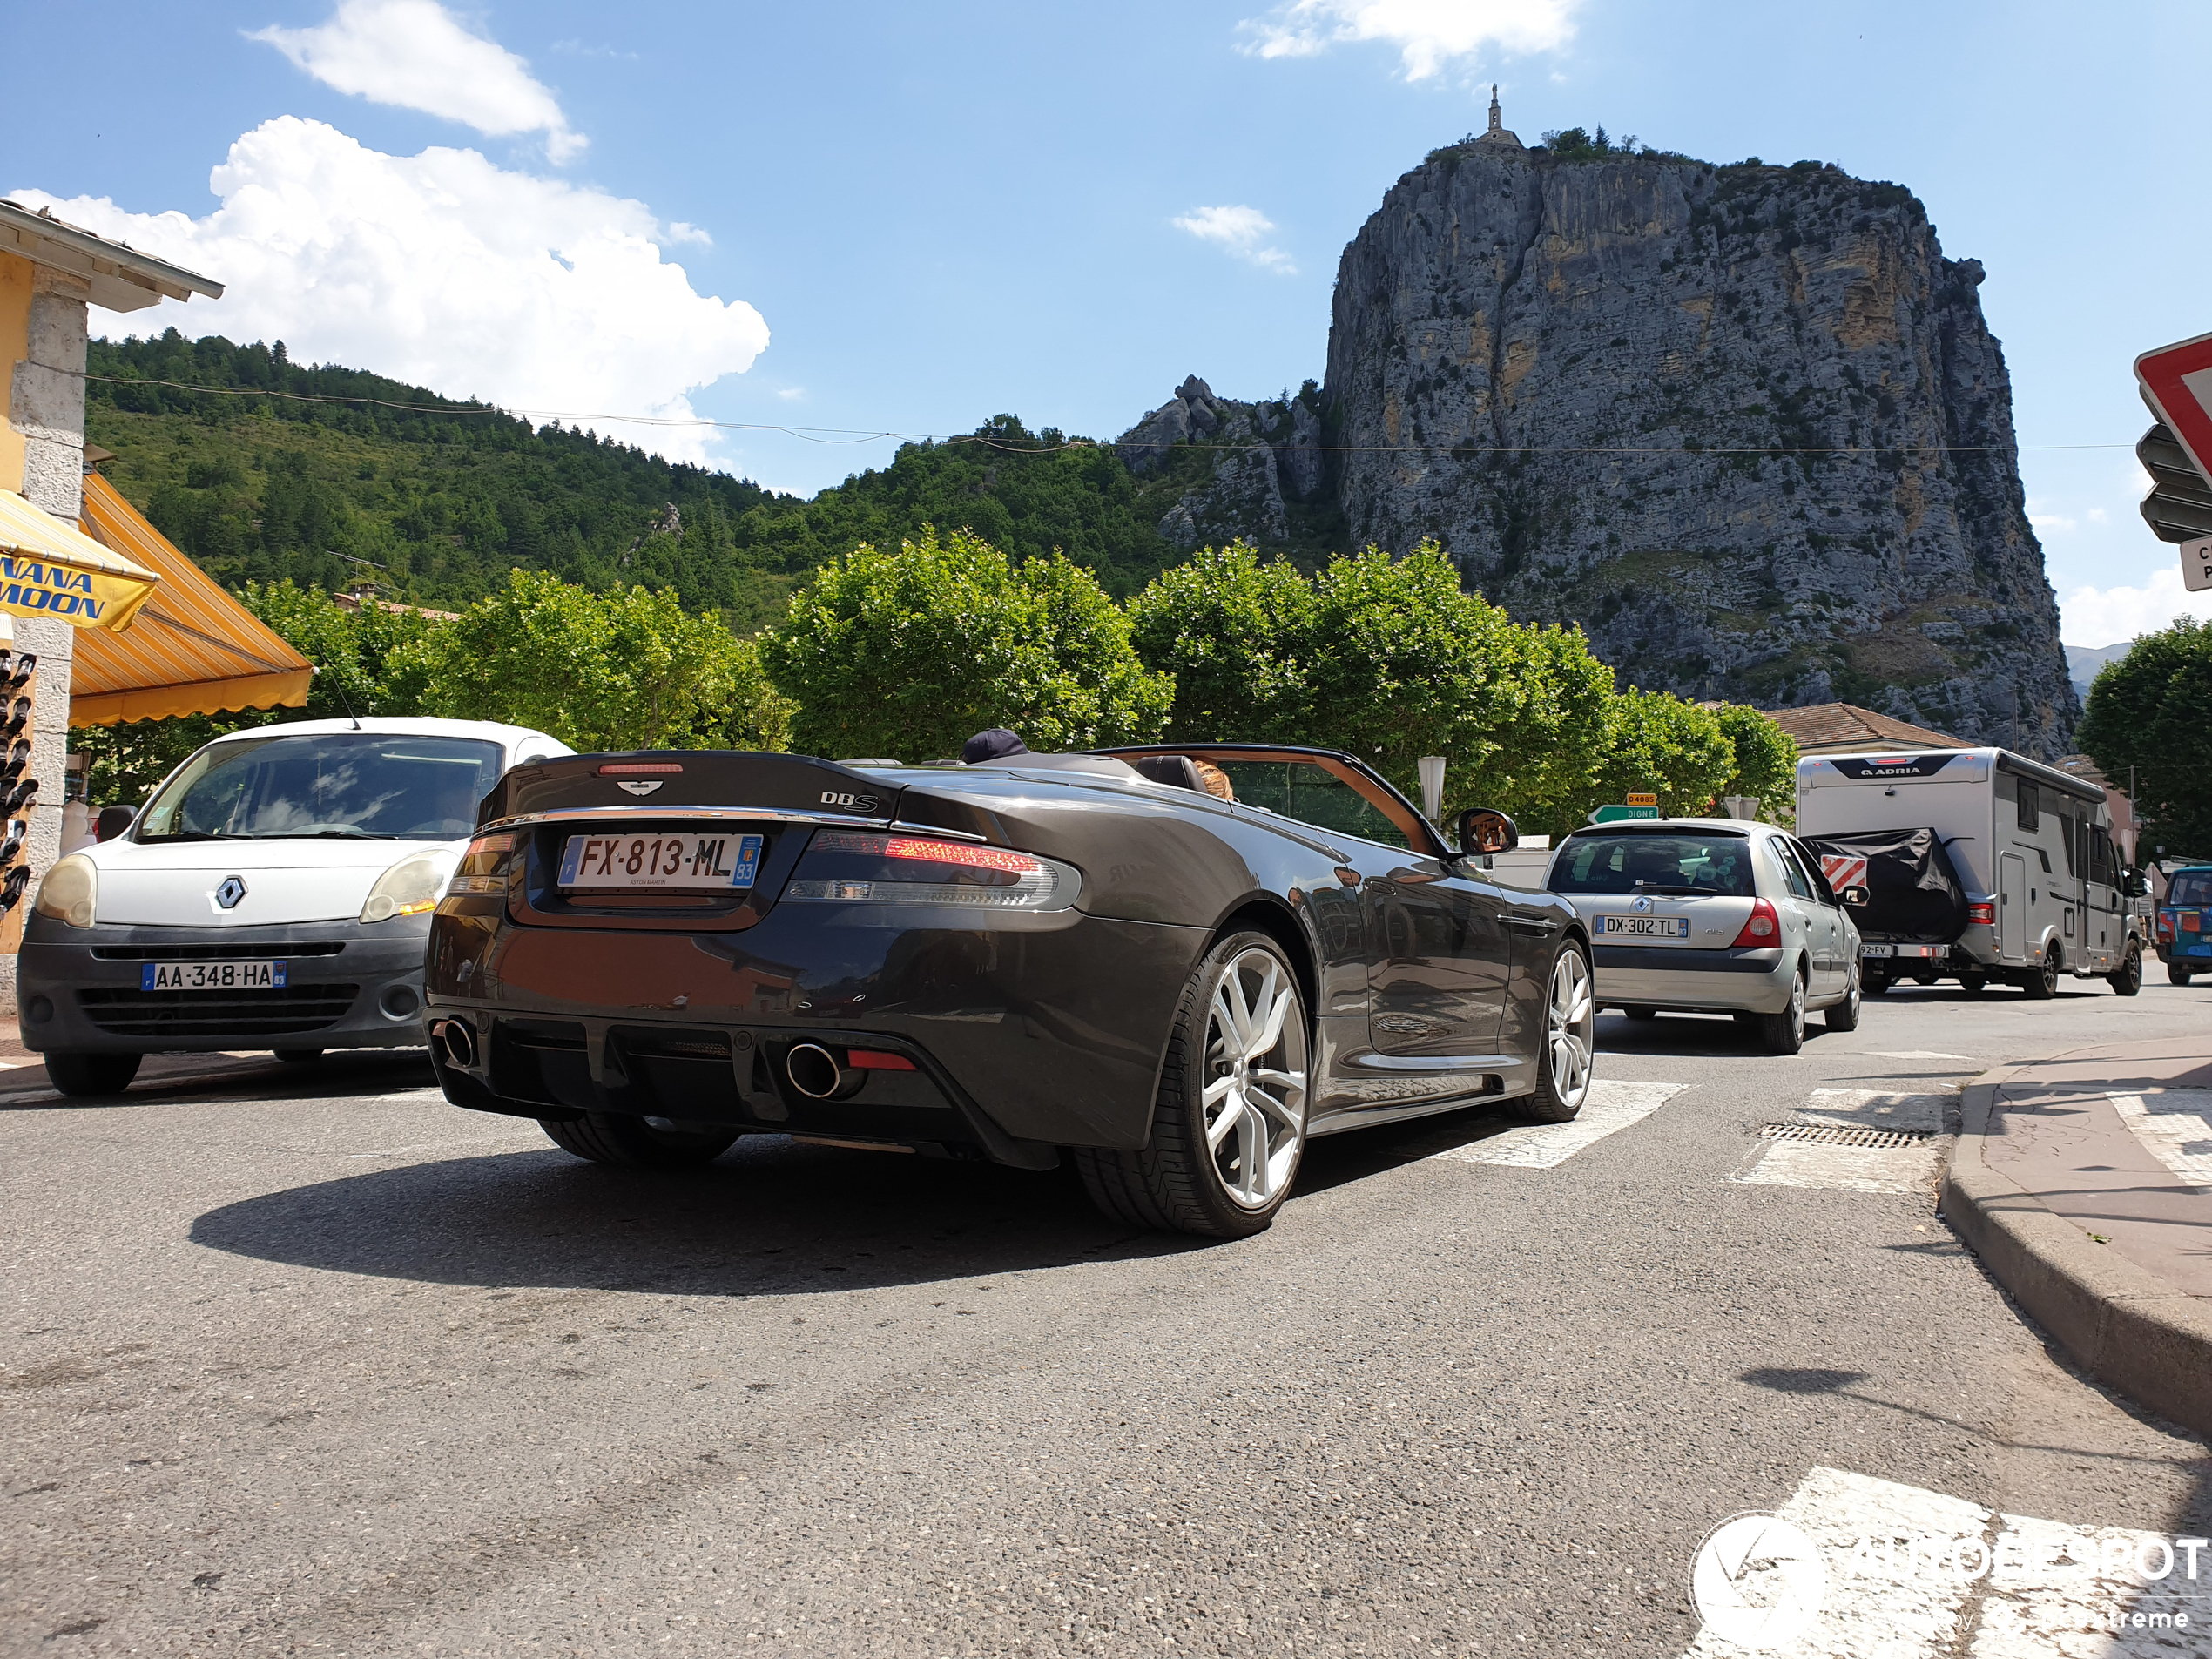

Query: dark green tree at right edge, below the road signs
[{"left": 2075, "top": 617, "right": 2212, "bottom": 859}]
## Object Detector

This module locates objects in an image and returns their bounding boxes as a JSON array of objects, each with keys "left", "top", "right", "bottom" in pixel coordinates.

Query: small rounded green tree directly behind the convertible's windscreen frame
[{"left": 1128, "top": 542, "right": 1314, "bottom": 743}]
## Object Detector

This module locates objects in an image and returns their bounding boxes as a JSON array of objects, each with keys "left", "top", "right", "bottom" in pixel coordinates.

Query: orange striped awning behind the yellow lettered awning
[{"left": 69, "top": 474, "right": 314, "bottom": 725}]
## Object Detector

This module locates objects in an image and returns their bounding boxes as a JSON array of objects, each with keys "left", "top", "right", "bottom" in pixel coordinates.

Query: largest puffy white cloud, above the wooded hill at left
[{"left": 16, "top": 115, "right": 767, "bottom": 460}]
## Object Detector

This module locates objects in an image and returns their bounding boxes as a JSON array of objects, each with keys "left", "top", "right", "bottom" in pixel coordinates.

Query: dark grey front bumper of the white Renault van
[{"left": 16, "top": 914, "right": 429, "bottom": 1055}]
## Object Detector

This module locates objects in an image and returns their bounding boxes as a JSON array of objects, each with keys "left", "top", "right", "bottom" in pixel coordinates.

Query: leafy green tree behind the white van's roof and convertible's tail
[{"left": 422, "top": 570, "right": 767, "bottom": 750}]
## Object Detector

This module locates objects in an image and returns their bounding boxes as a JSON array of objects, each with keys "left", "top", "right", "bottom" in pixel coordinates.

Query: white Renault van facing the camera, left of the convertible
[{"left": 16, "top": 719, "right": 570, "bottom": 1095}]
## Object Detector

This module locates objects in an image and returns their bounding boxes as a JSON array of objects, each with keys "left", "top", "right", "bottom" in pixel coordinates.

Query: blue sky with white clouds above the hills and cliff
[{"left": 0, "top": 0, "right": 2212, "bottom": 644}]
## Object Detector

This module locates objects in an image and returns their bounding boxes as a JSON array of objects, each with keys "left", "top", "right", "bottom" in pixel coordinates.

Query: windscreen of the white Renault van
[{"left": 137, "top": 732, "right": 502, "bottom": 840}]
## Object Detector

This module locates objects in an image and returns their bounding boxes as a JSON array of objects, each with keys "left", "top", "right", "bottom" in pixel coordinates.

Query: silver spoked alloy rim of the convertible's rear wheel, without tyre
[{"left": 1201, "top": 949, "right": 1305, "bottom": 1210}]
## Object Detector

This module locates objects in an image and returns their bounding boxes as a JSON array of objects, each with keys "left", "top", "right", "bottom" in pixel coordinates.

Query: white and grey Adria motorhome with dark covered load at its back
[{"left": 1796, "top": 748, "right": 2143, "bottom": 995}]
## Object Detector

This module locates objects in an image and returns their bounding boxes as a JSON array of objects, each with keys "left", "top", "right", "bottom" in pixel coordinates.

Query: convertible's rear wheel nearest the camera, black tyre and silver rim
[{"left": 1070, "top": 934, "right": 1312, "bottom": 1238}]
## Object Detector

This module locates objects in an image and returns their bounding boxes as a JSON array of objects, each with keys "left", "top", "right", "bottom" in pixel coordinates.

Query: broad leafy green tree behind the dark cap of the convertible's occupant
[{"left": 761, "top": 529, "right": 1175, "bottom": 761}]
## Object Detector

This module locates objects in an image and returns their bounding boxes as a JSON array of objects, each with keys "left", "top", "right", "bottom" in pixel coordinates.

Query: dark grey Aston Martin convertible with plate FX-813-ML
[{"left": 427, "top": 745, "right": 1595, "bottom": 1237}]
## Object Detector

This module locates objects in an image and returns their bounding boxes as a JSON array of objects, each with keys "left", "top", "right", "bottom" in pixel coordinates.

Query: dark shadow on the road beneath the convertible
[{"left": 190, "top": 1123, "right": 1214, "bottom": 1296}]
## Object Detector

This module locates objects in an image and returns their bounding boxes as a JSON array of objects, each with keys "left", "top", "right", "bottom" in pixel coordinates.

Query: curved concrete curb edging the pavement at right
[{"left": 1942, "top": 1066, "right": 2212, "bottom": 1435}]
